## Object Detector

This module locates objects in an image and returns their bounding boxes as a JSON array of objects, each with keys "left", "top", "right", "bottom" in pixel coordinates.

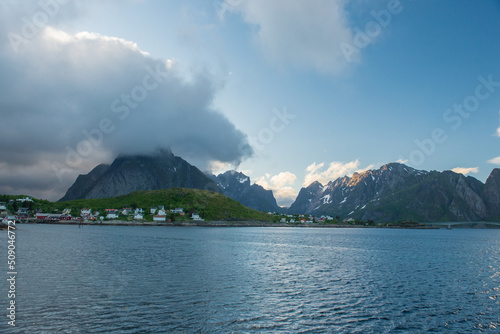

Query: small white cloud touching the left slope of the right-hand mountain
[{"left": 303, "top": 160, "right": 362, "bottom": 187}]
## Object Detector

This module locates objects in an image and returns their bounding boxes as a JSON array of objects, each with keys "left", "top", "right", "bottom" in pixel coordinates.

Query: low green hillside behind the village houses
[{"left": 28, "top": 188, "right": 272, "bottom": 221}]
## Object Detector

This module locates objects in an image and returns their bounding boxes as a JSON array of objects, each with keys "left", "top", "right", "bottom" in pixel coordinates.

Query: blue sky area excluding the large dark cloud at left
[{"left": 0, "top": 0, "right": 500, "bottom": 205}]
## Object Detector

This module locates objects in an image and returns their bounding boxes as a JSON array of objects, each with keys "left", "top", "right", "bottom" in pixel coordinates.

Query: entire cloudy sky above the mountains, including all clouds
[{"left": 0, "top": 0, "right": 500, "bottom": 206}]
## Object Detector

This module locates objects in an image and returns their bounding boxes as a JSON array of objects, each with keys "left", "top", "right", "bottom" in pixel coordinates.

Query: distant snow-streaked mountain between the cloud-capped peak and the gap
[{"left": 207, "top": 170, "right": 282, "bottom": 212}]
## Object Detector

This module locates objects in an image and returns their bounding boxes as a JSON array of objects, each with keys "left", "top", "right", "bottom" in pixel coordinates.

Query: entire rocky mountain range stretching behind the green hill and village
[{"left": 60, "top": 150, "right": 500, "bottom": 222}]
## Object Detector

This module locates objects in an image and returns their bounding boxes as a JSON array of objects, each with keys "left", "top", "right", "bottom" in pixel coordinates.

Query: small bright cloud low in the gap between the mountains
[{"left": 255, "top": 172, "right": 297, "bottom": 206}]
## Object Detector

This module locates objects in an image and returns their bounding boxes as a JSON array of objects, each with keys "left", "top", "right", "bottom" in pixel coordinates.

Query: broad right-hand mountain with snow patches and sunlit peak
[{"left": 289, "top": 163, "right": 500, "bottom": 221}]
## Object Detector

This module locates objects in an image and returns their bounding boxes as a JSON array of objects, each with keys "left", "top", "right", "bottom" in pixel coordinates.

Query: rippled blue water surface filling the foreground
[{"left": 0, "top": 225, "right": 500, "bottom": 333}]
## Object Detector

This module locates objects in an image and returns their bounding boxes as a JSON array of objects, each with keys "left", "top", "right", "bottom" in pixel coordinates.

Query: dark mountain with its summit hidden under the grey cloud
[{"left": 60, "top": 150, "right": 221, "bottom": 201}]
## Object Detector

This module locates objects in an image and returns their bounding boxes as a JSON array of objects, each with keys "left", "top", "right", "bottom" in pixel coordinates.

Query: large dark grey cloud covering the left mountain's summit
[{"left": 0, "top": 1, "right": 252, "bottom": 199}]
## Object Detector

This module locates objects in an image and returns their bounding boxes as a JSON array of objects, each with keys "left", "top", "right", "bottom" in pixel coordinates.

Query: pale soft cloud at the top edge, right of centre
[{"left": 227, "top": 0, "right": 353, "bottom": 74}]
